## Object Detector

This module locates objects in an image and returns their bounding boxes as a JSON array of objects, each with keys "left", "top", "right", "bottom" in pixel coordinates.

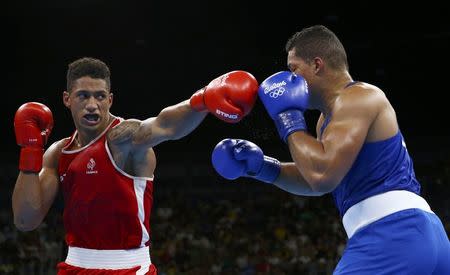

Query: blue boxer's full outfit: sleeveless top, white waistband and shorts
[{"left": 326, "top": 82, "right": 450, "bottom": 275}]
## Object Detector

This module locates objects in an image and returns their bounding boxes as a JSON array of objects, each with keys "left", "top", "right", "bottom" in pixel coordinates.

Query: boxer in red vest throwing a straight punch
[{"left": 12, "top": 58, "right": 258, "bottom": 275}]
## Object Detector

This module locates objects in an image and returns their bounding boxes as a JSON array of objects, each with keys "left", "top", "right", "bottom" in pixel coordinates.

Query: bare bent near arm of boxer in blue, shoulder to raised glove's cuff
[{"left": 288, "top": 87, "right": 386, "bottom": 193}]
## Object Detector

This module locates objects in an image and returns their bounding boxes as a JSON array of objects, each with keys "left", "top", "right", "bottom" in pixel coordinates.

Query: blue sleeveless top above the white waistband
[{"left": 320, "top": 98, "right": 420, "bottom": 216}]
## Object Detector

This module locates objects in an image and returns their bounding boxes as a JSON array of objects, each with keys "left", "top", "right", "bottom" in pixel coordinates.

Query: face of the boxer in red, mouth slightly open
[{"left": 63, "top": 76, "right": 113, "bottom": 135}]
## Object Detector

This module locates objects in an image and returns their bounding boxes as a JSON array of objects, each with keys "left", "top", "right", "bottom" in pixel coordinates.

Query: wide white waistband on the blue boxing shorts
[{"left": 342, "top": 190, "right": 433, "bottom": 239}]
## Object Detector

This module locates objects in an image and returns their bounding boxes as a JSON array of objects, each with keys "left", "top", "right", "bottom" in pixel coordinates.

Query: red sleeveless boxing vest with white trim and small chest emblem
[{"left": 58, "top": 118, "right": 153, "bottom": 249}]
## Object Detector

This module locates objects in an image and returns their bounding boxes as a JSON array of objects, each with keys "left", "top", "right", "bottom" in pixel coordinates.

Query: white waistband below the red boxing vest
[{"left": 66, "top": 246, "right": 151, "bottom": 269}]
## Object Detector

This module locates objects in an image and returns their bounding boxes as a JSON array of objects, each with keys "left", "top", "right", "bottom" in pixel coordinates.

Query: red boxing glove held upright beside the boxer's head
[{"left": 14, "top": 102, "right": 53, "bottom": 173}]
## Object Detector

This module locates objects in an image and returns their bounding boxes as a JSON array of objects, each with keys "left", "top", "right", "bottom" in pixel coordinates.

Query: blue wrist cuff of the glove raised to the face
[{"left": 274, "top": 110, "right": 307, "bottom": 142}]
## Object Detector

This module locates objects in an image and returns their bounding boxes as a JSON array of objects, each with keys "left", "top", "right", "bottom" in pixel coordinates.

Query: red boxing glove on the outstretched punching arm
[{"left": 190, "top": 71, "right": 258, "bottom": 123}]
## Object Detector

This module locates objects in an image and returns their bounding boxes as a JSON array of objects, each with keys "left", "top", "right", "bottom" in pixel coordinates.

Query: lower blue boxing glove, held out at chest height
[{"left": 211, "top": 138, "right": 281, "bottom": 183}]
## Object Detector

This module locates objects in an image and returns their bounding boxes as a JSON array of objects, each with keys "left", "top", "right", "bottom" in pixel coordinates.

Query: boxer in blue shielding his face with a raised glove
[{"left": 212, "top": 25, "right": 450, "bottom": 275}]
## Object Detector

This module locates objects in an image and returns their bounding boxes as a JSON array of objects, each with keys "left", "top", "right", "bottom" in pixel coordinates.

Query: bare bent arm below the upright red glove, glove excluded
[{"left": 12, "top": 141, "right": 64, "bottom": 231}]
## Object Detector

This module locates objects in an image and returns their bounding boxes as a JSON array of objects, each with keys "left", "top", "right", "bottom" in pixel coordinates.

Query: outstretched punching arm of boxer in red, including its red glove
[{"left": 108, "top": 71, "right": 258, "bottom": 150}]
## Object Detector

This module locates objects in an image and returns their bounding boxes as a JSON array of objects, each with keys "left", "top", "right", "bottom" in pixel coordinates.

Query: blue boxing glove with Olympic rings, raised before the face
[{"left": 258, "top": 71, "right": 309, "bottom": 142}]
